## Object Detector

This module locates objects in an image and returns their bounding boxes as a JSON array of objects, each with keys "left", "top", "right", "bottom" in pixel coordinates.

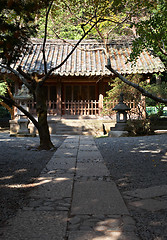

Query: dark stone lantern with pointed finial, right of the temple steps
[{"left": 109, "top": 93, "right": 130, "bottom": 137}]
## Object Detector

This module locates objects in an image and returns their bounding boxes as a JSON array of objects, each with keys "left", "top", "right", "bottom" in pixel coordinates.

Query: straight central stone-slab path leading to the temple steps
[{"left": 0, "top": 136, "right": 139, "bottom": 240}]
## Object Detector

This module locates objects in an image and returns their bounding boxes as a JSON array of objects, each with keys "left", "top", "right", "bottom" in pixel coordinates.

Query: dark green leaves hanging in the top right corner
[{"left": 131, "top": 0, "right": 167, "bottom": 64}]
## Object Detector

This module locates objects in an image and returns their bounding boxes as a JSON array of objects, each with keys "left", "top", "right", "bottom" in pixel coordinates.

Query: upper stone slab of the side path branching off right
[{"left": 123, "top": 185, "right": 167, "bottom": 199}]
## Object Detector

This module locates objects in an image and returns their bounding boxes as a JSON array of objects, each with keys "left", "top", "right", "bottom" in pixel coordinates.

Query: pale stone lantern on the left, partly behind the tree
[{"left": 10, "top": 84, "right": 32, "bottom": 136}]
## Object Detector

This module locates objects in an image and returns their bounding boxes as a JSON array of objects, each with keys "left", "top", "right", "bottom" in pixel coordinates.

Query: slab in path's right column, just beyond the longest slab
[{"left": 76, "top": 162, "right": 110, "bottom": 176}]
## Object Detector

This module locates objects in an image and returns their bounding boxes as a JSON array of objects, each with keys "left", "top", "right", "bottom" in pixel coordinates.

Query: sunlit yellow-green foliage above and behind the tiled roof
[{"left": 38, "top": 0, "right": 138, "bottom": 40}]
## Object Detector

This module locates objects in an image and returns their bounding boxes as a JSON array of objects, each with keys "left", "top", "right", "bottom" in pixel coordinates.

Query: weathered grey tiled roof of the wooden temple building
[{"left": 2, "top": 39, "right": 165, "bottom": 76}]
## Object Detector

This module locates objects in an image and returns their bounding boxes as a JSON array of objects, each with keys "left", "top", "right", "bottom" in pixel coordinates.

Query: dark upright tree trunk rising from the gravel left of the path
[{"left": 35, "top": 83, "right": 54, "bottom": 150}]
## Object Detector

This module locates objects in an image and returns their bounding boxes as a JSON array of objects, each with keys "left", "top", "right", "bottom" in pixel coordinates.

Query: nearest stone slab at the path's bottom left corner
[{"left": 2, "top": 211, "right": 67, "bottom": 240}]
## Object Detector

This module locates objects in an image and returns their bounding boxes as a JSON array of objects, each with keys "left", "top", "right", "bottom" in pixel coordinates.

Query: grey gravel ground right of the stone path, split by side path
[{"left": 95, "top": 134, "right": 167, "bottom": 240}]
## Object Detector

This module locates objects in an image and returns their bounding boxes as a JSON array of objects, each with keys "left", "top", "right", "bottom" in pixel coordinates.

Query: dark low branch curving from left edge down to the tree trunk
[{"left": 0, "top": 95, "right": 39, "bottom": 130}]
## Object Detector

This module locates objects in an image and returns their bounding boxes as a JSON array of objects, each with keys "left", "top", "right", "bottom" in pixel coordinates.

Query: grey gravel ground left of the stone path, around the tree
[{"left": 0, "top": 133, "right": 65, "bottom": 227}]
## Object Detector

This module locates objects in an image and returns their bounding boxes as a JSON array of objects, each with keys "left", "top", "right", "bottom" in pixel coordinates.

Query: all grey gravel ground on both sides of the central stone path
[{"left": 0, "top": 133, "right": 167, "bottom": 240}]
